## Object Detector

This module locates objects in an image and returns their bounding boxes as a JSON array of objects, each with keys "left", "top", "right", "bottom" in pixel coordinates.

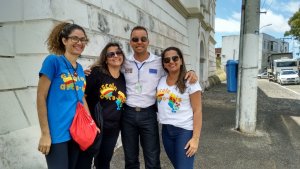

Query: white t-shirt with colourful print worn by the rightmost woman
[{"left": 156, "top": 76, "right": 202, "bottom": 130}]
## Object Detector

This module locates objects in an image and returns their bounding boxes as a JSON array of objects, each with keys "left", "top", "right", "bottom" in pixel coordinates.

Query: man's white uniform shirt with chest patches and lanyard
[{"left": 121, "top": 53, "right": 165, "bottom": 108}]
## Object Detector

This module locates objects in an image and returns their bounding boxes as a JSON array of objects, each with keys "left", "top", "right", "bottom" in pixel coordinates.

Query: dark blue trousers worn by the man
[{"left": 121, "top": 105, "right": 161, "bottom": 169}]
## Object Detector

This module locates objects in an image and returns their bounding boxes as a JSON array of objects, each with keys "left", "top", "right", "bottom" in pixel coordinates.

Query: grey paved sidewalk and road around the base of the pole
[{"left": 112, "top": 80, "right": 300, "bottom": 169}]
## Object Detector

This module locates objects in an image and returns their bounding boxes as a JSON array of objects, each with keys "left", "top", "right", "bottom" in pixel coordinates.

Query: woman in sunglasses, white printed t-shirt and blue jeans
[{"left": 156, "top": 47, "right": 202, "bottom": 169}]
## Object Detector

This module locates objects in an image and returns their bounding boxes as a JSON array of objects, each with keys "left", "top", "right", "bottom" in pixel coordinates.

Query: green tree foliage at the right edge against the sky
[{"left": 284, "top": 8, "right": 300, "bottom": 40}]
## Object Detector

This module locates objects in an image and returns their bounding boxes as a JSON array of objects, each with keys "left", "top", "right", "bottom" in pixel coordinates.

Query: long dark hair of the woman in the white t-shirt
[{"left": 161, "top": 46, "right": 187, "bottom": 94}]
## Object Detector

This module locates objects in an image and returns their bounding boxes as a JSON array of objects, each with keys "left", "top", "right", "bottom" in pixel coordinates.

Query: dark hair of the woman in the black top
[{"left": 91, "top": 42, "right": 125, "bottom": 75}]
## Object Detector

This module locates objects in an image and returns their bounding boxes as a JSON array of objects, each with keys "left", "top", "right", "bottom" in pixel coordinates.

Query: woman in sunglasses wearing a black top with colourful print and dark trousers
[{"left": 78, "top": 43, "right": 126, "bottom": 169}]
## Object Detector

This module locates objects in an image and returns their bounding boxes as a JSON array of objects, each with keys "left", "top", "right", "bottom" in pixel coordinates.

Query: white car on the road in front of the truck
[{"left": 277, "top": 70, "right": 300, "bottom": 85}]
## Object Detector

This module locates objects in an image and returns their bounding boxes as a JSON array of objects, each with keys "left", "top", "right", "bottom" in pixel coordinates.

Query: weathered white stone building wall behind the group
[{"left": 0, "top": 0, "right": 216, "bottom": 168}]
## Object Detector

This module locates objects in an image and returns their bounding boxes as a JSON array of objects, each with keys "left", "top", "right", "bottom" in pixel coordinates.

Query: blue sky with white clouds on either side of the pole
[{"left": 215, "top": 0, "right": 300, "bottom": 57}]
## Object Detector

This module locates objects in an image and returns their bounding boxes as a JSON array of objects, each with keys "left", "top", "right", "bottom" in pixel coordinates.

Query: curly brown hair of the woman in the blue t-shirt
[{"left": 46, "top": 22, "right": 87, "bottom": 55}]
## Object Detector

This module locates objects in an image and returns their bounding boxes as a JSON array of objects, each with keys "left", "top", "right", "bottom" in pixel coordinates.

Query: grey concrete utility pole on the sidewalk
[{"left": 236, "top": 0, "right": 260, "bottom": 134}]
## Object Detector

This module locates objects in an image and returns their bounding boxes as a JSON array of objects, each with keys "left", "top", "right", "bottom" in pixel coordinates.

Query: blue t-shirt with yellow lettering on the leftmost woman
[{"left": 39, "top": 55, "right": 86, "bottom": 144}]
